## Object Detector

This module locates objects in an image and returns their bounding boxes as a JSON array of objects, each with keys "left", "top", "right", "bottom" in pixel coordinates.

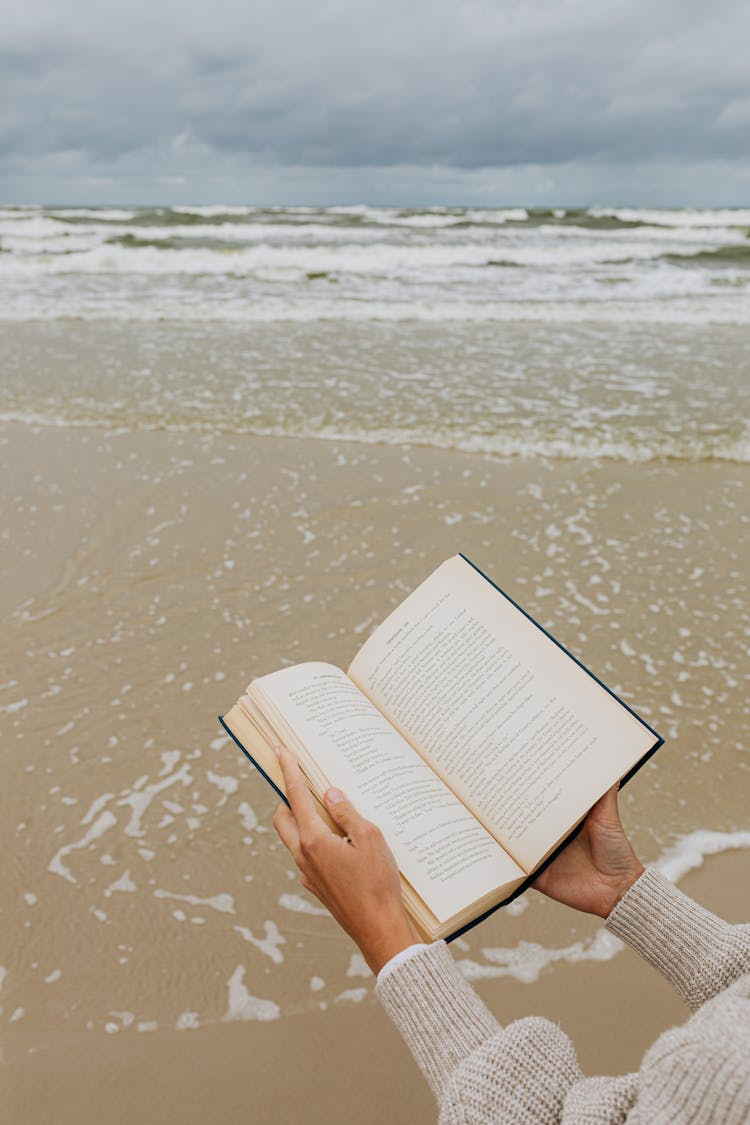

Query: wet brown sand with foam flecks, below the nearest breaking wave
[{"left": 0, "top": 425, "right": 750, "bottom": 1123}]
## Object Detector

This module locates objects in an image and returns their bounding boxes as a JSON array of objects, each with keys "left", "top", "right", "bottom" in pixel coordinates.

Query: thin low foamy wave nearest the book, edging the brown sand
[{"left": 0, "top": 404, "right": 750, "bottom": 464}]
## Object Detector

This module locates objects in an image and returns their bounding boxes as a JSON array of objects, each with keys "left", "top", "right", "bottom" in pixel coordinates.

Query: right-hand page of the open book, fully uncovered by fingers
[{"left": 349, "top": 556, "right": 654, "bottom": 871}]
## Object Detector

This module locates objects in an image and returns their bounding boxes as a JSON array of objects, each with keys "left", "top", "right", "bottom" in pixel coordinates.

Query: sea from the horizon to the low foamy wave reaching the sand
[{"left": 0, "top": 205, "right": 750, "bottom": 461}]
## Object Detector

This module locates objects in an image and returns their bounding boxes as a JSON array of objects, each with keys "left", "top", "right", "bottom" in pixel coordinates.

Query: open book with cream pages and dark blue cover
[{"left": 220, "top": 555, "right": 662, "bottom": 941}]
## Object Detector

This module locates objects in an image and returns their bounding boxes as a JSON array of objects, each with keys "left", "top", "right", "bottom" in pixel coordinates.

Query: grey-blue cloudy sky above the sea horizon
[{"left": 0, "top": 0, "right": 750, "bottom": 206}]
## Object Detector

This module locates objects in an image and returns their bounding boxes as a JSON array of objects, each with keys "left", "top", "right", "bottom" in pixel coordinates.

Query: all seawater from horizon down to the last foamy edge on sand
[{"left": 0, "top": 206, "right": 750, "bottom": 1050}]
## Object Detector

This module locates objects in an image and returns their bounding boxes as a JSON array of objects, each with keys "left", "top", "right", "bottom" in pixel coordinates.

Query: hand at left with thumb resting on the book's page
[{"left": 273, "top": 746, "right": 421, "bottom": 974}]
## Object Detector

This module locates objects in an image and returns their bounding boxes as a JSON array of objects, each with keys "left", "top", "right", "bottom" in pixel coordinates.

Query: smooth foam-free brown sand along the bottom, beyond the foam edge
[{"left": 6, "top": 853, "right": 750, "bottom": 1125}]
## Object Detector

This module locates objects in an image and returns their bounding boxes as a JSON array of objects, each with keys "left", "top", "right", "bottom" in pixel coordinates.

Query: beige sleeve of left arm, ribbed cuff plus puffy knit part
[{"left": 376, "top": 942, "right": 582, "bottom": 1125}]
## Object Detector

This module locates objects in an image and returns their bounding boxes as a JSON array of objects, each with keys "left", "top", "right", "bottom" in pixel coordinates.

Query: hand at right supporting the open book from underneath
[{"left": 533, "top": 785, "right": 643, "bottom": 918}]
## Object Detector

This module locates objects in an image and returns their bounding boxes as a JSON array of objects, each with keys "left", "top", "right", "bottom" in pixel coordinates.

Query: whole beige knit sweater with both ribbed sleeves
[{"left": 376, "top": 869, "right": 750, "bottom": 1125}]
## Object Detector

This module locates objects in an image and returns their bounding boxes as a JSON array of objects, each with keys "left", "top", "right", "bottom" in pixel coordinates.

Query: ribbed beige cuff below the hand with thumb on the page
[{"left": 376, "top": 942, "right": 500, "bottom": 1101}]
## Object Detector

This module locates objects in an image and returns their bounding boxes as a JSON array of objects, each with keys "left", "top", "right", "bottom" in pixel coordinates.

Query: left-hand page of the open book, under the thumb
[{"left": 253, "top": 663, "right": 523, "bottom": 921}]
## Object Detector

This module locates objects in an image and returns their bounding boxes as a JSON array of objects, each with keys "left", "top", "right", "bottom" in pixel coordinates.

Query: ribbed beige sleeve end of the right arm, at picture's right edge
[{"left": 606, "top": 867, "right": 750, "bottom": 1010}]
